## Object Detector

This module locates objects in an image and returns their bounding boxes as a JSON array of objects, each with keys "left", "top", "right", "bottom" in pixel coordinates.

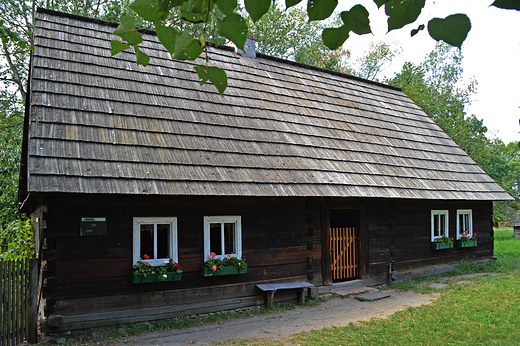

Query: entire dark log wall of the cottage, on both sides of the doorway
[{"left": 36, "top": 195, "right": 493, "bottom": 326}]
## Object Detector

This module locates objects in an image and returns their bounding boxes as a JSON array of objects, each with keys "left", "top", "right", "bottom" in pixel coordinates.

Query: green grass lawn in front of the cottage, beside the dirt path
[{"left": 219, "top": 229, "right": 520, "bottom": 346}]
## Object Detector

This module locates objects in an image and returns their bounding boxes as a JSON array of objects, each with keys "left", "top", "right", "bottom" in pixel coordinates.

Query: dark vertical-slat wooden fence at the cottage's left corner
[{"left": 0, "top": 250, "right": 38, "bottom": 346}]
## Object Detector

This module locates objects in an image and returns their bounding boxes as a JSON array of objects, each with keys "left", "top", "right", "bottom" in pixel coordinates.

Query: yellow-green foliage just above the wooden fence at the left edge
[{"left": 0, "top": 219, "right": 34, "bottom": 259}]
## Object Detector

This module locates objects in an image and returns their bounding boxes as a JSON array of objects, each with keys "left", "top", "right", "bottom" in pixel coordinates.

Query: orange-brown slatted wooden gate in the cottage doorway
[{"left": 330, "top": 227, "right": 359, "bottom": 281}]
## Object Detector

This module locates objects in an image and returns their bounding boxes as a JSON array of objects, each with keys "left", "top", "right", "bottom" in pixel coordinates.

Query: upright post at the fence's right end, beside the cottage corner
[{"left": 27, "top": 258, "right": 40, "bottom": 344}]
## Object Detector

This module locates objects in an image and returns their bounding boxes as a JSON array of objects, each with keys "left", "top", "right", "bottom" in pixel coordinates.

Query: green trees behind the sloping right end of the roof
[{"left": 387, "top": 43, "right": 520, "bottom": 223}]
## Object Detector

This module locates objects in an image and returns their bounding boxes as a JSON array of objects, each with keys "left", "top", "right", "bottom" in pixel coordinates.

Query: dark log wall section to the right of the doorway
[{"left": 365, "top": 200, "right": 493, "bottom": 278}]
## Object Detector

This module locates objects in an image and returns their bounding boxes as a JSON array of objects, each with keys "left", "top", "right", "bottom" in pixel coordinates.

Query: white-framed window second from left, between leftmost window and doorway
[{"left": 204, "top": 216, "right": 242, "bottom": 260}]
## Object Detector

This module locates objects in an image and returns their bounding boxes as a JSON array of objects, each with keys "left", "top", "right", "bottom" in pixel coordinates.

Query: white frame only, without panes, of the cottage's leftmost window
[{"left": 133, "top": 217, "right": 179, "bottom": 266}]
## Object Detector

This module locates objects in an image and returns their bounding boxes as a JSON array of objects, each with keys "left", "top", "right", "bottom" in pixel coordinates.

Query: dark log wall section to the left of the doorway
[{"left": 39, "top": 195, "right": 321, "bottom": 315}]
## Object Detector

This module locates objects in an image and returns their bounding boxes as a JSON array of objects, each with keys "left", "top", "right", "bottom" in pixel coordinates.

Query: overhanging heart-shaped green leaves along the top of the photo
[{"left": 112, "top": 0, "right": 514, "bottom": 95}]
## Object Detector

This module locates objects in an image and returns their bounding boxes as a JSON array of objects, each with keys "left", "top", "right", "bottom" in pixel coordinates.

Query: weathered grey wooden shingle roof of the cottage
[{"left": 24, "top": 10, "right": 511, "bottom": 200}]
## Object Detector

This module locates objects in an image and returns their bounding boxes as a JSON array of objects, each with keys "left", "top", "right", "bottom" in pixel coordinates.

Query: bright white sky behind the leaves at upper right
[{"left": 339, "top": 0, "right": 520, "bottom": 143}]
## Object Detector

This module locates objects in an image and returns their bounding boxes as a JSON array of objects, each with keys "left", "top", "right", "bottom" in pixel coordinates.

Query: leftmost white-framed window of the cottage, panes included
[{"left": 133, "top": 217, "right": 178, "bottom": 266}]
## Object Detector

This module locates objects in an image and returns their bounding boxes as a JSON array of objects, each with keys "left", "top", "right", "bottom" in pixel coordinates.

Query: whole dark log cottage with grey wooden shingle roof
[{"left": 20, "top": 10, "right": 511, "bottom": 330}]
